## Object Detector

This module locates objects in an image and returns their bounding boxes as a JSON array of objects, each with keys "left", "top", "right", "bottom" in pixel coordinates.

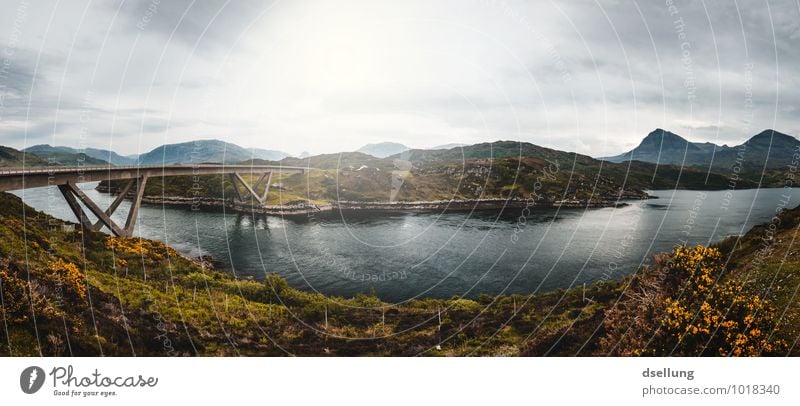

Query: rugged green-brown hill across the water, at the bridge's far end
[{"left": 109, "top": 141, "right": 756, "bottom": 206}]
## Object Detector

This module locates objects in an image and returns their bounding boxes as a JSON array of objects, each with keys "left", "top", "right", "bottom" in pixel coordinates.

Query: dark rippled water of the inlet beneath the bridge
[{"left": 15, "top": 183, "right": 800, "bottom": 302}]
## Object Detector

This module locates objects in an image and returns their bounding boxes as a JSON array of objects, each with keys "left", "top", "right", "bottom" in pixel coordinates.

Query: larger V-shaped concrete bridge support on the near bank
[{"left": 58, "top": 176, "right": 147, "bottom": 237}]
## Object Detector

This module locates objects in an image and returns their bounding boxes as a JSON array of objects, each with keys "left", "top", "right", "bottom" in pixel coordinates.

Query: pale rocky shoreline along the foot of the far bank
[{"left": 97, "top": 183, "right": 651, "bottom": 216}]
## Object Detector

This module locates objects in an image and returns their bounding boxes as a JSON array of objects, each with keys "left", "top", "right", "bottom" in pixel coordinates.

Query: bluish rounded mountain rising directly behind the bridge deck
[{"left": 139, "top": 140, "right": 288, "bottom": 165}]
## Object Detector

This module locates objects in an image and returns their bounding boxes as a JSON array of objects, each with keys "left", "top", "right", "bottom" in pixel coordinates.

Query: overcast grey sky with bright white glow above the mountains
[{"left": 0, "top": 0, "right": 800, "bottom": 157}]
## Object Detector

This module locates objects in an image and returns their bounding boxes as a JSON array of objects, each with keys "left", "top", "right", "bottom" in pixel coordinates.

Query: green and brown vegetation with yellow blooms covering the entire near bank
[{"left": 0, "top": 189, "right": 800, "bottom": 356}]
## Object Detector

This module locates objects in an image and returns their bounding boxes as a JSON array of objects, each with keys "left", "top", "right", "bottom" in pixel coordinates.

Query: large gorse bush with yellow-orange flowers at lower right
[{"left": 601, "top": 245, "right": 786, "bottom": 356}]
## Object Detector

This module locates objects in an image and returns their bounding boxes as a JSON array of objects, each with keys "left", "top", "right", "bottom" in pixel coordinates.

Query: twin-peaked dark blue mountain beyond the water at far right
[{"left": 601, "top": 128, "right": 800, "bottom": 173}]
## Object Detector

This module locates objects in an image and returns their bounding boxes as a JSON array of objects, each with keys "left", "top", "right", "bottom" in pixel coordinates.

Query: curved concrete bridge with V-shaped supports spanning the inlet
[{"left": 0, "top": 164, "right": 309, "bottom": 237}]
